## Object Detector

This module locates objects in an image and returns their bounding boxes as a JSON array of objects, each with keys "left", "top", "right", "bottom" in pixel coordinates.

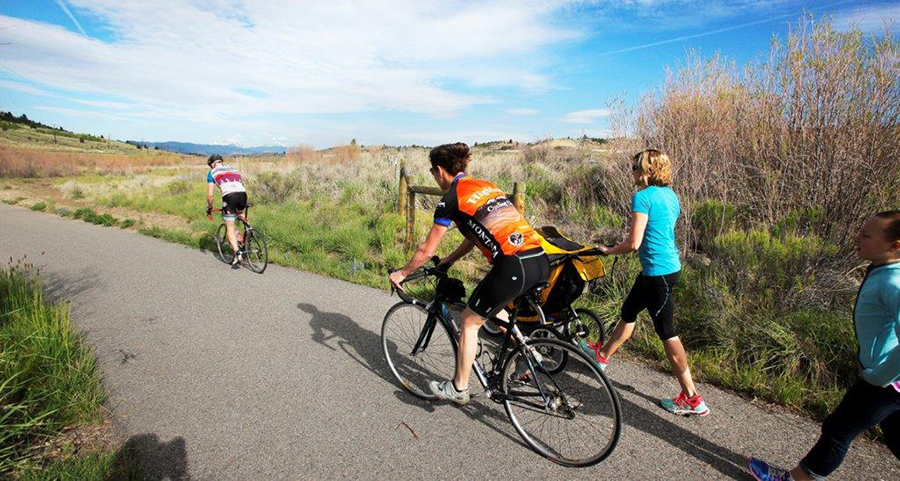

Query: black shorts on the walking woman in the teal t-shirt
[{"left": 622, "top": 271, "right": 681, "bottom": 341}]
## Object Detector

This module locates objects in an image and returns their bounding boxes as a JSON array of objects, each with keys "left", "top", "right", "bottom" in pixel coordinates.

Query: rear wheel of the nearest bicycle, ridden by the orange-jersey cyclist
[{"left": 501, "top": 339, "right": 622, "bottom": 467}]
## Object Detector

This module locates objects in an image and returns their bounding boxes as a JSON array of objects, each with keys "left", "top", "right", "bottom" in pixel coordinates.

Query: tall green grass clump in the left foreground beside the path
[{"left": 0, "top": 262, "right": 105, "bottom": 473}]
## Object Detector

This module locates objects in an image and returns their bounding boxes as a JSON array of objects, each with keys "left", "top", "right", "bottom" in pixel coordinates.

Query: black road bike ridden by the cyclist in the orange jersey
[{"left": 381, "top": 259, "right": 622, "bottom": 467}]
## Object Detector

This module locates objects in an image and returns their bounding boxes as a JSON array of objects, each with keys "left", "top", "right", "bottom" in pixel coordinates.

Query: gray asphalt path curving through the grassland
[{"left": 0, "top": 201, "right": 900, "bottom": 479}]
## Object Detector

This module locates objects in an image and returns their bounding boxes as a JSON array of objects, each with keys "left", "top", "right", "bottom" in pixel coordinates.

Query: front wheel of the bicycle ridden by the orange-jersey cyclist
[{"left": 381, "top": 302, "right": 458, "bottom": 401}]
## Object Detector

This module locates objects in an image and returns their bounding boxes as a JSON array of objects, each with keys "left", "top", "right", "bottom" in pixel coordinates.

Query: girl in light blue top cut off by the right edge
[{"left": 750, "top": 210, "right": 900, "bottom": 481}]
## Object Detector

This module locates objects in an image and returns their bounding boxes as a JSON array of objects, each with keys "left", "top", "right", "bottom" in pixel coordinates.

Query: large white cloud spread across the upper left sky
[{"left": 0, "top": 0, "right": 579, "bottom": 127}]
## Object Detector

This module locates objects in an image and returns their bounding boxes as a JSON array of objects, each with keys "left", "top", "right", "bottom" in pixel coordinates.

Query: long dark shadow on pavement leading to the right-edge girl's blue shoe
[{"left": 613, "top": 382, "right": 747, "bottom": 479}]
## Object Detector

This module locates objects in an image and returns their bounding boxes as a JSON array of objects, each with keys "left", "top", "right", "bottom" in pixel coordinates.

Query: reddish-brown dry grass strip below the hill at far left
[{"left": 0, "top": 148, "right": 190, "bottom": 178}]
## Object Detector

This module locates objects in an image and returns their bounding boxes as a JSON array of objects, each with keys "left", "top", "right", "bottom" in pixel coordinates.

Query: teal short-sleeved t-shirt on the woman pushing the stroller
[{"left": 631, "top": 185, "right": 681, "bottom": 276}]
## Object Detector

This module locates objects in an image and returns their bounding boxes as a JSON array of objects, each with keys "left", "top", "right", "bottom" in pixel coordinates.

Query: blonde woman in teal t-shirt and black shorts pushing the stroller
[{"left": 582, "top": 149, "right": 709, "bottom": 416}]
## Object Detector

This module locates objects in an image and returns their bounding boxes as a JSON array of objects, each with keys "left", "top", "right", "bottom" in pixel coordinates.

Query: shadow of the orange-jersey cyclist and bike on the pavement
[{"left": 297, "top": 302, "right": 527, "bottom": 449}]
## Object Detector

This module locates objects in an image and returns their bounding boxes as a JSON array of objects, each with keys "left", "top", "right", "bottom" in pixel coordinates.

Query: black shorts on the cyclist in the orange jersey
[{"left": 469, "top": 248, "right": 550, "bottom": 319}]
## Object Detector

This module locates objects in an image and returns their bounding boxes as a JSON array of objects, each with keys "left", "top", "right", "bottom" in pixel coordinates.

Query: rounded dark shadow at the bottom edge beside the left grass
[{"left": 107, "top": 433, "right": 190, "bottom": 481}]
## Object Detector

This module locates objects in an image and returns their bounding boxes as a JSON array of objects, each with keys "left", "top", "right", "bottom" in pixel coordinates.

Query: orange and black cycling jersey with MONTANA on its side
[{"left": 434, "top": 174, "right": 541, "bottom": 264}]
